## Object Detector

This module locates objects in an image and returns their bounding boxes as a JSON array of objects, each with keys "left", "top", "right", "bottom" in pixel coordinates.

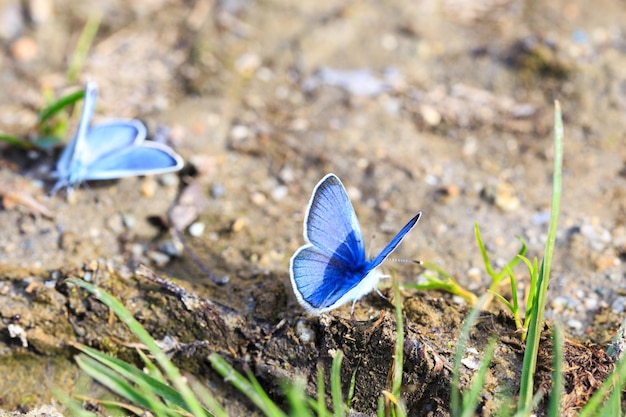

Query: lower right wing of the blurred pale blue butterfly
[{"left": 82, "top": 142, "right": 183, "bottom": 180}]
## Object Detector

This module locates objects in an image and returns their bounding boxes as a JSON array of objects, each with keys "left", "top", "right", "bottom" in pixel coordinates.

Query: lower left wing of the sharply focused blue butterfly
[{"left": 289, "top": 240, "right": 365, "bottom": 313}]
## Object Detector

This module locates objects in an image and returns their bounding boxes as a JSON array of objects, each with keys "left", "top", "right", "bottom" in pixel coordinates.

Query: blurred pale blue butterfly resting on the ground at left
[{"left": 50, "top": 81, "right": 183, "bottom": 194}]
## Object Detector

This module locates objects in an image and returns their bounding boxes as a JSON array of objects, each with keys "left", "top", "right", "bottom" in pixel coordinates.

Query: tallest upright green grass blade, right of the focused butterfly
[{"left": 518, "top": 101, "right": 564, "bottom": 409}]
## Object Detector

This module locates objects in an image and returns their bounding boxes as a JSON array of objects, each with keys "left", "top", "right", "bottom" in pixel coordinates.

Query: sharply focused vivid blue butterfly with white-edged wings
[{"left": 289, "top": 174, "right": 422, "bottom": 314}]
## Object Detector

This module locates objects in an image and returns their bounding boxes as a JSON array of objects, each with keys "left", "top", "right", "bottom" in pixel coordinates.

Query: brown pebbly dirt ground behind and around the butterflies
[{"left": 0, "top": 0, "right": 626, "bottom": 415}]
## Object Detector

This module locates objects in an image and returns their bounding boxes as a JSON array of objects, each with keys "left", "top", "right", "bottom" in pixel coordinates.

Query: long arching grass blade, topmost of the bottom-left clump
[{"left": 67, "top": 278, "right": 211, "bottom": 416}]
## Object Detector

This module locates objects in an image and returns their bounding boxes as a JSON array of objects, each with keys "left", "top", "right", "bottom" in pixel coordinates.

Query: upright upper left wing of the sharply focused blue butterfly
[{"left": 304, "top": 174, "right": 365, "bottom": 268}]
